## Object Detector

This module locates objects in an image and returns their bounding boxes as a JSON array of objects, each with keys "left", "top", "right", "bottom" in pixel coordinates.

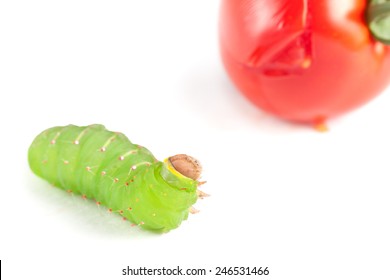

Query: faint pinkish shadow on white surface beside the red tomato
[{"left": 181, "top": 66, "right": 298, "bottom": 133}]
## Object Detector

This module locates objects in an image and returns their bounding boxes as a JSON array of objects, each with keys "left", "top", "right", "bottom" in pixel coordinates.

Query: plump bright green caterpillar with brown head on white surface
[{"left": 28, "top": 125, "right": 206, "bottom": 232}]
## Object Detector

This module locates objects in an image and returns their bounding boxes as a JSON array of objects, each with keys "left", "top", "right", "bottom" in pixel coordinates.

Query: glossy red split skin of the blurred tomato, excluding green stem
[{"left": 219, "top": 0, "right": 390, "bottom": 123}]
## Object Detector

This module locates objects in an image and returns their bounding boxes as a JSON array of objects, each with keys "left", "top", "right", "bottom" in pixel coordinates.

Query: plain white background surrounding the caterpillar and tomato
[{"left": 0, "top": 0, "right": 390, "bottom": 280}]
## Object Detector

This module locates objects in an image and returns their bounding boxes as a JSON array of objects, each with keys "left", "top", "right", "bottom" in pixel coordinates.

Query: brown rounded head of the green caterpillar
[{"left": 169, "top": 154, "right": 202, "bottom": 180}]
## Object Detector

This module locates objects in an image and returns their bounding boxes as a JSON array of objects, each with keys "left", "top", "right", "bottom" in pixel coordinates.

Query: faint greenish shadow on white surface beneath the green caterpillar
[{"left": 24, "top": 172, "right": 160, "bottom": 239}]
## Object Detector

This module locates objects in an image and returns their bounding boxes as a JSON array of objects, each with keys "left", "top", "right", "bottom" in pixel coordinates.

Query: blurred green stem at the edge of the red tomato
[{"left": 366, "top": 0, "right": 390, "bottom": 45}]
